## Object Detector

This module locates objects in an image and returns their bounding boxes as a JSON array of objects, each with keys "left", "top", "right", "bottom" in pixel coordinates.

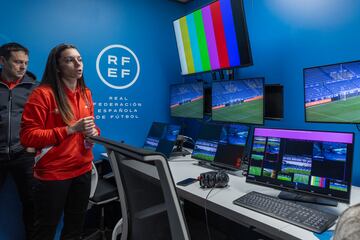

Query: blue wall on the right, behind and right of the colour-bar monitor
[{"left": 179, "top": 0, "right": 360, "bottom": 186}]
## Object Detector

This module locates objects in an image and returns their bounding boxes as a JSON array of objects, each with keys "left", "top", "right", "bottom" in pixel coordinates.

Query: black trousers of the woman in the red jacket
[{"left": 33, "top": 172, "right": 91, "bottom": 240}]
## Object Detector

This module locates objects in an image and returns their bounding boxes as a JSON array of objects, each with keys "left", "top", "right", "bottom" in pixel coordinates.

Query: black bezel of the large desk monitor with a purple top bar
[{"left": 246, "top": 127, "right": 355, "bottom": 203}]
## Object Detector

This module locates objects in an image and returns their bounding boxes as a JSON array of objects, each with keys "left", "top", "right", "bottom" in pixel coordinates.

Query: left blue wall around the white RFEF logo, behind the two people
[{"left": 0, "top": 0, "right": 185, "bottom": 240}]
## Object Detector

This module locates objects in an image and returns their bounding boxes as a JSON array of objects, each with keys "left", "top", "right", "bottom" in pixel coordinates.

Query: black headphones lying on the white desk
[{"left": 198, "top": 171, "right": 229, "bottom": 188}]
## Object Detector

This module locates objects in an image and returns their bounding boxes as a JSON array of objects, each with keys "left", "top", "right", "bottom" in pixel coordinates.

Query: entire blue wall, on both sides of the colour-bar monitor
[{"left": 0, "top": 0, "right": 360, "bottom": 239}]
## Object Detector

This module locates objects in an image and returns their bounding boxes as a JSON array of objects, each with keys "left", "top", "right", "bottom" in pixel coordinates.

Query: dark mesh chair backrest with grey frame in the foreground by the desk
[{"left": 91, "top": 137, "right": 190, "bottom": 240}]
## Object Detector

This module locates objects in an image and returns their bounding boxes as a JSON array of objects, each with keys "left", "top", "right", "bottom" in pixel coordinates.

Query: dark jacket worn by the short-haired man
[{"left": 0, "top": 69, "right": 38, "bottom": 158}]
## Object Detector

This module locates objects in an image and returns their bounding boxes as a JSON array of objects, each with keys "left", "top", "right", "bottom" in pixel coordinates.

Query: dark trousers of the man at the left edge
[{"left": 0, "top": 150, "right": 35, "bottom": 239}]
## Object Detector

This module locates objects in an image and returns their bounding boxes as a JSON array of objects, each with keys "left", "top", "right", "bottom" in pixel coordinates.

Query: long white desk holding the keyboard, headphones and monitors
[{"left": 169, "top": 156, "right": 360, "bottom": 240}]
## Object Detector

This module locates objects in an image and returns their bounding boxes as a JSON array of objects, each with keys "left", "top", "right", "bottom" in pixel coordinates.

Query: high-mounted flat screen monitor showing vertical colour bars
[{"left": 173, "top": 0, "right": 252, "bottom": 75}]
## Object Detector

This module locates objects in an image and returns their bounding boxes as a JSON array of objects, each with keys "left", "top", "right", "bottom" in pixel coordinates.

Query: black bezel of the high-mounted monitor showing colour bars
[{"left": 173, "top": 0, "right": 254, "bottom": 76}]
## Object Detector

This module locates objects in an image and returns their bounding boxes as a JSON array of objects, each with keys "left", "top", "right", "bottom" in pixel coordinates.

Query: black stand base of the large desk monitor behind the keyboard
[{"left": 278, "top": 191, "right": 338, "bottom": 207}]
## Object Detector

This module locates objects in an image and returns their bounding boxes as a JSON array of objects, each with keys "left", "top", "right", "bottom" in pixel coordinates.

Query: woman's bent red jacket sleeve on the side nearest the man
[{"left": 20, "top": 89, "right": 67, "bottom": 149}]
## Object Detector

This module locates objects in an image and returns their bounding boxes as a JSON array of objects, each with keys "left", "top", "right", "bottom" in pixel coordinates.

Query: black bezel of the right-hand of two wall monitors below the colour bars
[{"left": 211, "top": 77, "right": 265, "bottom": 126}]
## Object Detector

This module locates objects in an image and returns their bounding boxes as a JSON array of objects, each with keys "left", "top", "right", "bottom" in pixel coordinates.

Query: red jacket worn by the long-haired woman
[{"left": 20, "top": 85, "right": 99, "bottom": 180}]
